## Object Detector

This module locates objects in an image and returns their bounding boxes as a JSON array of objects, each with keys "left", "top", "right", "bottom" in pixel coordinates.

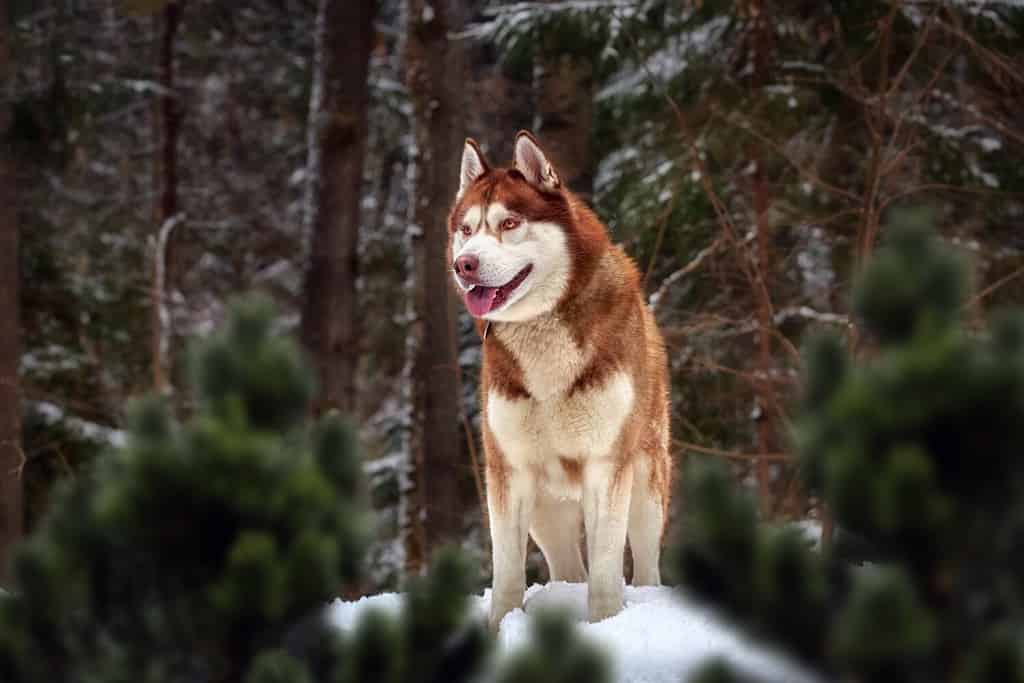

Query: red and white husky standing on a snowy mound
[{"left": 449, "top": 132, "right": 672, "bottom": 630}]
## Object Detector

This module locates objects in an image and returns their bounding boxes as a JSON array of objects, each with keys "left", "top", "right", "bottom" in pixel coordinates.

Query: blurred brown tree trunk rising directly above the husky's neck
[{"left": 534, "top": 6, "right": 594, "bottom": 199}]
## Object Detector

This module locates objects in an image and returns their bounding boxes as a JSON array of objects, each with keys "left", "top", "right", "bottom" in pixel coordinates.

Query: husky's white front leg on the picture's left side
[{"left": 487, "top": 468, "right": 537, "bottom": 633}]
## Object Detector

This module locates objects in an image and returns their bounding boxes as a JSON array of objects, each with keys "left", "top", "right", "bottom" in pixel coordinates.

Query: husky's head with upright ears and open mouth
[{"left": 449, "top": 131, "right": 603, "bottom": 322}]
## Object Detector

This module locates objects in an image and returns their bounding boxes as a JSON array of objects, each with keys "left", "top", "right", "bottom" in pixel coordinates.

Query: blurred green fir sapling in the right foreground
[{"left": 677, "top": 213, "right": 1024, "bottom": 683}]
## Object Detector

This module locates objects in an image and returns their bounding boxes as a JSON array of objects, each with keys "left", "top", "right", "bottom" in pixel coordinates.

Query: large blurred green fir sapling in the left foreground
[{"left": 0, "top": 300, "right": 369, "bottom": 681}]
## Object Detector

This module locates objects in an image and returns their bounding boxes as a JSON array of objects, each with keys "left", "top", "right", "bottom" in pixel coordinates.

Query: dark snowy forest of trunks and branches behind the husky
[{"left": 0, "top": 0, "right": 1024, "bottom": 591}]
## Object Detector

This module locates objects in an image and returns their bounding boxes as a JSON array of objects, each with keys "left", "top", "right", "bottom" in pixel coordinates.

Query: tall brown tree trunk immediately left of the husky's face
[{"left": 404, "top": 0, "right": 465, "bottom": 569}]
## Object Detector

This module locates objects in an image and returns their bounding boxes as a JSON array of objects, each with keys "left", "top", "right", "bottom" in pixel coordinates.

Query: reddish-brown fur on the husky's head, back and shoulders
[{"left": 449, "top": 141, "right": 672, "bottom": 524}]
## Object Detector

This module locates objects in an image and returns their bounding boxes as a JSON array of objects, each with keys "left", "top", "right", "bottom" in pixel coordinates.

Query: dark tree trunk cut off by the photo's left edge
[{"left": 0, "top": 0, "right": 25, "bottom": 582}]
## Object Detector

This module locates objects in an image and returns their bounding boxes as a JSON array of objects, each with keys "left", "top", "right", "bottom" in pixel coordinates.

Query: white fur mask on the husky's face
[{"left": 452, "top": 202, "right": 569, "bottom": 322}]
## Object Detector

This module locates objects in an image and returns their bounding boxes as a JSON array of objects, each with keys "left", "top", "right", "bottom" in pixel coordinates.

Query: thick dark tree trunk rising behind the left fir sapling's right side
[{"left": 302, "top": 0, "right": 376, "bottom": 414}]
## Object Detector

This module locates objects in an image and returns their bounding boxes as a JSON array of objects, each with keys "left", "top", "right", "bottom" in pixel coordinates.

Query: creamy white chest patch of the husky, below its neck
[{"left": 486, "top": 321, "right": 634, "bottom": 482}]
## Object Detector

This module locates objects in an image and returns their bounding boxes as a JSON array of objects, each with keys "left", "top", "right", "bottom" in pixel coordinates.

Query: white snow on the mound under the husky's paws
[{"left": 331, "top": 583, "right": 815, "bottom": 683}]
